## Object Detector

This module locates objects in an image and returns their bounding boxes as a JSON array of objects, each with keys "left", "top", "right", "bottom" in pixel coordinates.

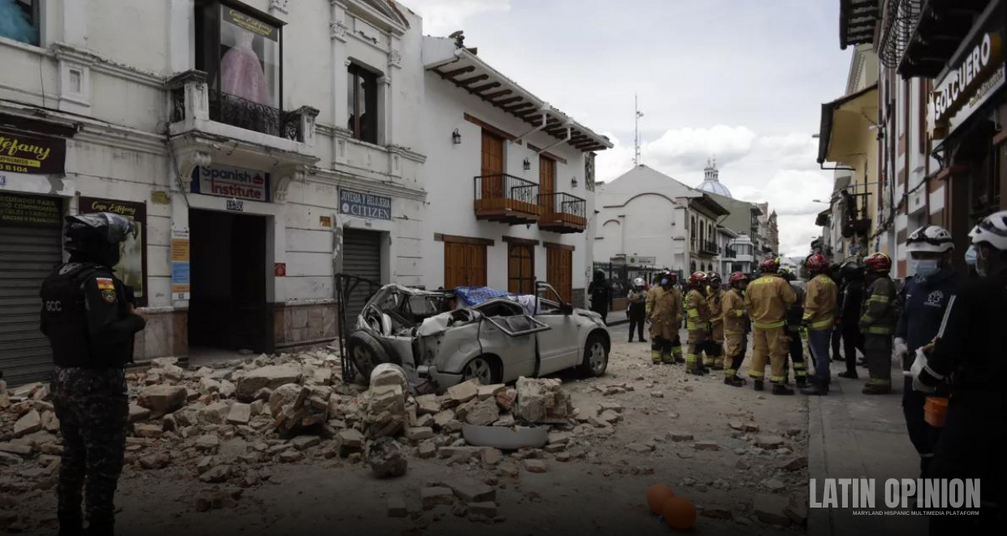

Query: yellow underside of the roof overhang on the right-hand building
[{"left": 818, "top": 84, "right": 878, "bottom": 164}]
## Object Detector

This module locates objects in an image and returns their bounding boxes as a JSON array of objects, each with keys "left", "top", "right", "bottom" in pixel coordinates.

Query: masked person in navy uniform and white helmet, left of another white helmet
[{"left": 894, "top": 226, "right": 960, "bottom": 477}]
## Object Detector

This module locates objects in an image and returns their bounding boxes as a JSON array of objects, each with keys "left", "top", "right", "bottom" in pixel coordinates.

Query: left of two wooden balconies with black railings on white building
[{"left": 474, "top": 173, "right": 542, "bottom": 225}]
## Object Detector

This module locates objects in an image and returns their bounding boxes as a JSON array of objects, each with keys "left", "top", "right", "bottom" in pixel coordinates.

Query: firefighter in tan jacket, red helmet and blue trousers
[{"left": 801, "top": 253, "right": 839, "bottom": 395}]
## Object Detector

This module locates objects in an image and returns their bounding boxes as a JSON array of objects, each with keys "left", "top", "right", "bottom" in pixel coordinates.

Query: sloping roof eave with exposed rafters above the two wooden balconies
[{"left": 423, "top": 37, "right": 613, "bottom": 152}]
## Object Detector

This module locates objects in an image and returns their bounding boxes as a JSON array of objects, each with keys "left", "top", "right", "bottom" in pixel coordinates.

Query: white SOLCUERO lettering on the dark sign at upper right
[{"left": 933, "top": 33, "right": 1000, "bottom": 123}]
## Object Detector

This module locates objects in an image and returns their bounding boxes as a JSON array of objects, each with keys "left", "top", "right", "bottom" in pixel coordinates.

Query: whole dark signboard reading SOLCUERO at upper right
[{"left": 929, "top": 32, "right": 1005, "bottom": 138}]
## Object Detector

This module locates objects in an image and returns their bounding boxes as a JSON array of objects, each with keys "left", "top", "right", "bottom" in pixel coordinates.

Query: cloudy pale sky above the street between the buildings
[{"left": 401, "top": 0, "right": 852, "bottom": 256}]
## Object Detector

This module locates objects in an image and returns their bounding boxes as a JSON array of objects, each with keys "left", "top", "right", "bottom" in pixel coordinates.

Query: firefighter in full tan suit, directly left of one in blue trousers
[{"left": 745, "top": 257, "right": 798, "bottom": 395}]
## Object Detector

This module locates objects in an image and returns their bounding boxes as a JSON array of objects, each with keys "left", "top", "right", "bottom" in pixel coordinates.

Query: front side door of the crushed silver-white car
[{"left": 535, "top": 283, "right": 580, "bottom": 376}]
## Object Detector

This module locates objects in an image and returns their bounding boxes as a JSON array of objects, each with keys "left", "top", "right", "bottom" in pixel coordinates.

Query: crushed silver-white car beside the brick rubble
[{"left": 346, "top": 283, "right": 611, "bottom": 390}]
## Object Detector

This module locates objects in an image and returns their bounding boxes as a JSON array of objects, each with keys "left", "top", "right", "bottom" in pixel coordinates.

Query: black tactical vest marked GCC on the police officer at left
[{"left": 39, "top": 263, "right": 132, "bottom": 369}]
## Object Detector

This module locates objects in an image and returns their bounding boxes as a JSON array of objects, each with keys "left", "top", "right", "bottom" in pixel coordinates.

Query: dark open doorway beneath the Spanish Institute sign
[{"left": 188, "top": 210, "right": 275, "bottom": 354}]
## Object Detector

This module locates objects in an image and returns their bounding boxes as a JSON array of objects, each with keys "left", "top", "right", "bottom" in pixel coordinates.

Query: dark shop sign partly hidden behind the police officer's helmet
[{"left": 80, "top": 197, "right": 147, "bottom": 307}]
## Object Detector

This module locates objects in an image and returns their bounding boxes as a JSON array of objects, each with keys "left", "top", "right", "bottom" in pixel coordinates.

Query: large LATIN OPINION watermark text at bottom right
[{"left": 809, "top": 479, "right": 980, "bottom": 514}]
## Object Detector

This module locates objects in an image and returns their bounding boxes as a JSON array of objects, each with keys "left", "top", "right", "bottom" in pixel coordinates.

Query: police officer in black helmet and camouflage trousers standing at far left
[{"left": 40, "top": 213, "right": 146, "bottom": 535}]
